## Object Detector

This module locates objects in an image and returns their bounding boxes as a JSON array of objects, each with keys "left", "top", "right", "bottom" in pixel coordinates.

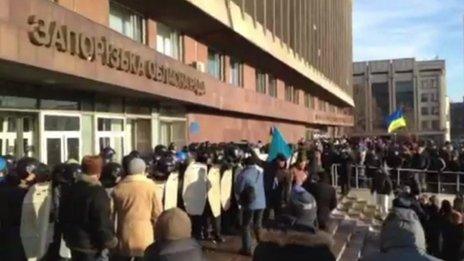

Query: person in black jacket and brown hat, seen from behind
[{"left": 60, "top": 156, "right": 118, "bottom": 261}]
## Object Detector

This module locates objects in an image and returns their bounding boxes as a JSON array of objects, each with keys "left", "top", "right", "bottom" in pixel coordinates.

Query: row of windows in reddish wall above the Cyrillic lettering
[{"left": 109, "top": 1, "right": 342, "bottom": 112}]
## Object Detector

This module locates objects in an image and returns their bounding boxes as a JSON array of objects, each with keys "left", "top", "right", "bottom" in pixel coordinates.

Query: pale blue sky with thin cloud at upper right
[{"left": 353, "top": 0, "right": 464, "bottom": 101}]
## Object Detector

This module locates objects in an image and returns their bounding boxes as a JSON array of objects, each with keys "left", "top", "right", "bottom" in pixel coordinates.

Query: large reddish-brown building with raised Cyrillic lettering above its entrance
[{"left": 0, "top": 0, "right": 354, "bottom": 164}]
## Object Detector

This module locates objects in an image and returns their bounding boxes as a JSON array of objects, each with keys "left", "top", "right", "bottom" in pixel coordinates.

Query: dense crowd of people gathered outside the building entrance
[{"left": 0, "top": 136, "right": 464, "bottom": 261}]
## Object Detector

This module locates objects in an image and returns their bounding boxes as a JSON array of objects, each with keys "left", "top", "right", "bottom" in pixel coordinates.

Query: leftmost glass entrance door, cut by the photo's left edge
[{"left": 0, "top": 111, "right": 37, "bottom": 158}]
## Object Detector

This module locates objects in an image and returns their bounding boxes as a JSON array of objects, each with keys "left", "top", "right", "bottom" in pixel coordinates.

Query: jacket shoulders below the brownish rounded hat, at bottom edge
[{"left": 144, "top": 238, "right": 203, "bottom": 261}]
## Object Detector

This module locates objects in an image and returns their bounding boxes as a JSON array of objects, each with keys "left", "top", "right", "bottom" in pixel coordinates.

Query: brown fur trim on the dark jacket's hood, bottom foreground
[{"left": 259, "top": 229, "right": 334, "bottom": 249}]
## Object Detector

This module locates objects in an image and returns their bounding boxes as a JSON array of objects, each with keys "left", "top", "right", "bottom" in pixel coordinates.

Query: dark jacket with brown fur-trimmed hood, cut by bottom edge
[{"left": 253, "top": 222, "right": 335, "bottom": 261}]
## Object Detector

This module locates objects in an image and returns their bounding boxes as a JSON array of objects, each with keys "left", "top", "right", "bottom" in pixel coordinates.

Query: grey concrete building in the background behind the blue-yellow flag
[{"left": 353, "top": 59, "right": 449, "bottom": 141}]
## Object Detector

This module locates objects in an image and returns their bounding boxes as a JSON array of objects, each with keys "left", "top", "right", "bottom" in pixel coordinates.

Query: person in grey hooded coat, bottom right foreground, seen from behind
[{"left": 362, "top": 204, "right": 439, "bottom": 261}]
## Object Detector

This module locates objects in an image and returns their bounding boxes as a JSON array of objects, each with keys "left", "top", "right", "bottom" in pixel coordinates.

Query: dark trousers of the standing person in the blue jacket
[{"left": 242, "top": 209, "right": 264, "bottom": 252}]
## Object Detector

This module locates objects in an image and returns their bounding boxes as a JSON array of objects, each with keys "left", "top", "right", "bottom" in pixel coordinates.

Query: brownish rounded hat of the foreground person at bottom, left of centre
[{"left": 155, "top": 208, "right": 192, "bottom": 241}]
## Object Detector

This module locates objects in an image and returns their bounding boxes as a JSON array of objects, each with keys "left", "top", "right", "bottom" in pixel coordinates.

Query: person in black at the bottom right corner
[{"left": 441, "top": 210, "right": 464, "bottom": 261}]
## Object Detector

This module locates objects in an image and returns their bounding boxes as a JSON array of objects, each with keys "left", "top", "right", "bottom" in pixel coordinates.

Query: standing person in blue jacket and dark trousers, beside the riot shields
[{"left": 235, "top": 157, "right": 266, "bottom": 255}]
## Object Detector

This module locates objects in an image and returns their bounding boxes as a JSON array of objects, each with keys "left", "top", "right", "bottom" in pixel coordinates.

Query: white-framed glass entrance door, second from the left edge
[{"left": 43, "top": 115, "right": 81, "bottom": 166}]
